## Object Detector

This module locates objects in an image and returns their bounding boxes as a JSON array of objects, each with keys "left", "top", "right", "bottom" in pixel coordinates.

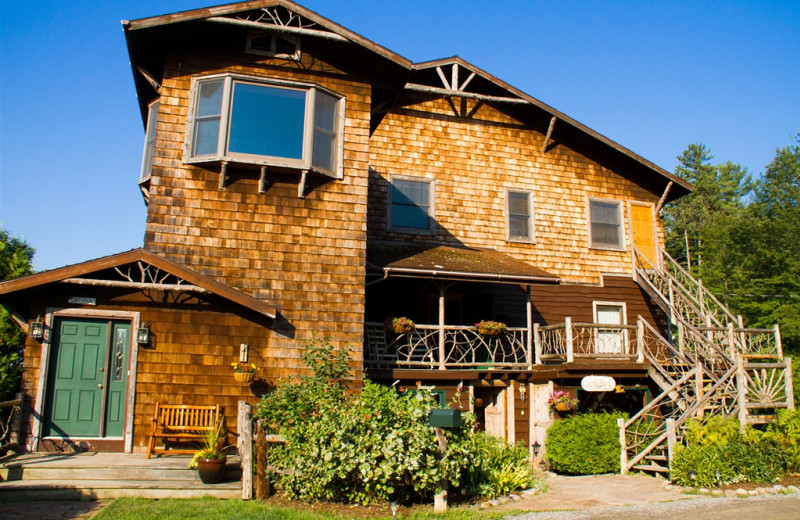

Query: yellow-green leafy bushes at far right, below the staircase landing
[{"left": 671, "top": 415, "right": 800, "bottom": 487}]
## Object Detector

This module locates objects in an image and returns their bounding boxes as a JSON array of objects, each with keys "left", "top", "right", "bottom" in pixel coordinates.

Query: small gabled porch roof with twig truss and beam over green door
[{"left": 0, "top": 248, "right": 277, "bottom": 318}]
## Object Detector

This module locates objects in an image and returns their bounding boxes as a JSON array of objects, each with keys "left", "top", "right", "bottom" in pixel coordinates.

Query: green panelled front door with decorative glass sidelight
[{"left": 44, "top": 318, "right": 130, "bottom": 437}]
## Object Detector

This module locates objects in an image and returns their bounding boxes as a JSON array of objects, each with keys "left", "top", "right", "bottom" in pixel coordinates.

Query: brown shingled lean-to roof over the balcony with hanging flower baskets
[{"left": 367, "top": 241, "right": 559, "bottom": 284}]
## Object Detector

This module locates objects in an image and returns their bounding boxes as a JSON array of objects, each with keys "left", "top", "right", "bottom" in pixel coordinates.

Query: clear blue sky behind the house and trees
[{"left": 0, "top": 0, "right": 800, "bottom": 270}]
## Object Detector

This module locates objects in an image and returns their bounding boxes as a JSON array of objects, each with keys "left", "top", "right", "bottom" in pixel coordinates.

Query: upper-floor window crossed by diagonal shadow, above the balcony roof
[{"left": 389, "top": 177, "right": 433, "bottom": 231}]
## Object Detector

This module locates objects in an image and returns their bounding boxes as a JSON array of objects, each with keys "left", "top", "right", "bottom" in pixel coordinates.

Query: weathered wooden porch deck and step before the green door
[{"left": 0, "top": 452, "right": 242, "bottom": 501}]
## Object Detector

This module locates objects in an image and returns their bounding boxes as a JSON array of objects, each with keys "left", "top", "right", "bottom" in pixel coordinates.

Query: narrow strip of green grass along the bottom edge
[{"left": 92, "top": 498, "right": 509, "bottom": 520}]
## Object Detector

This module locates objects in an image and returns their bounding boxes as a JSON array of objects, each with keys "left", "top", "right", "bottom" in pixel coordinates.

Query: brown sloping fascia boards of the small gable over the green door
[{"left": 0, "top": 248, "right": 277, "bottom": 318}]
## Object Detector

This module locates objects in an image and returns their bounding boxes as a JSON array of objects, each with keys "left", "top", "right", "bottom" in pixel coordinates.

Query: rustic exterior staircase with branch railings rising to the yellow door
[{"left": 619, "top": 248, "right": 794, "bottom": 474}]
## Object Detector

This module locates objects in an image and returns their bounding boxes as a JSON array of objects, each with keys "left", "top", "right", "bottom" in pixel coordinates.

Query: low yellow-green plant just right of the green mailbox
[{"left": 464, "top": 432, "right": 536, "bottom": 498}]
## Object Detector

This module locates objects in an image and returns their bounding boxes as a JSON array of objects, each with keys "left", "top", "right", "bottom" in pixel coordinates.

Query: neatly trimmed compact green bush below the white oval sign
[{"left": 545, "top": 413, "right": 626, "bottom": 475}]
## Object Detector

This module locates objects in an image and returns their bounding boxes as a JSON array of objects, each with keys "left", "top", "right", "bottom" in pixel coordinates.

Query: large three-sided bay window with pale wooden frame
[{"left": 186, "top": 75, "right": 344, "bottom": 177}]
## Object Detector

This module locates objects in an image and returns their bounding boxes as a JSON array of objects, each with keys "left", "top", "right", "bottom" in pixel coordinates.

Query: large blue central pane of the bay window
[{"left": 228, "top": 83, "right": 306, "bottom": 160}]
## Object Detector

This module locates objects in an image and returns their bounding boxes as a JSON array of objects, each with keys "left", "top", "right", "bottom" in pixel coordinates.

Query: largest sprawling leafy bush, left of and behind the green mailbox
[{"left": 256, "top": 341, "right": 529, "bottom": 504}]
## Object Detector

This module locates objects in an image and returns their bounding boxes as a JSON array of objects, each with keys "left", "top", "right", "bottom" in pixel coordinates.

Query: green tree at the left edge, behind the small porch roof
[{"left": 0, "top": 228, "right": 34, "bottom": 401}]
